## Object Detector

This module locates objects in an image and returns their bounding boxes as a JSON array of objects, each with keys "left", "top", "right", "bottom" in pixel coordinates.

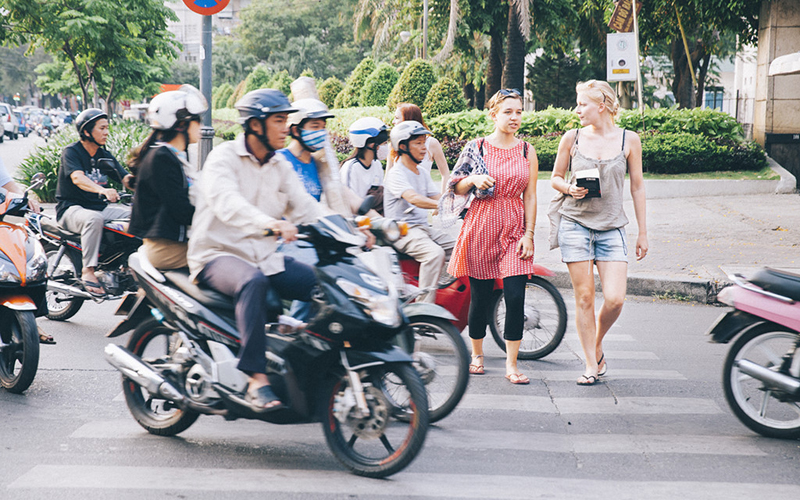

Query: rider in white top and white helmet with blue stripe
[{"left": 339, "top": 117, "right": 389, "bottom": 214}]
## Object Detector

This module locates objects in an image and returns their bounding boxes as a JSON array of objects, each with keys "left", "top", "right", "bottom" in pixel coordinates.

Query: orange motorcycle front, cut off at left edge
[{"left": 0, "top": 173, "right": 47, "bottom": 394}]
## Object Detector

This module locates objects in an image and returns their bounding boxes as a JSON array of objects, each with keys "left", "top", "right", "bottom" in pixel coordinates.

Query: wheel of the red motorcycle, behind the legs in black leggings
[{"left": 489, "top": 276, "right": 567, "bottom": 359}]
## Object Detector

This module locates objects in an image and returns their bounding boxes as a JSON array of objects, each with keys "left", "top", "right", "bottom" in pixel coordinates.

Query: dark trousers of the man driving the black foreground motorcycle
[{"left": 197, "top": 257, "right": 317, "bottom": 374}]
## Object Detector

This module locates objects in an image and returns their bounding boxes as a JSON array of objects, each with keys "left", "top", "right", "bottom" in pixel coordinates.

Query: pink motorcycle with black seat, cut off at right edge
[{"left": 708, "top": 268, "right": 800, "bottom": 438}]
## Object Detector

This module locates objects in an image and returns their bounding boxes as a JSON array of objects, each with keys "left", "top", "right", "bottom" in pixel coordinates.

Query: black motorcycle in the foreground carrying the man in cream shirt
[{"left": 106, "top": 215, "right": 429, "bottom": 477}]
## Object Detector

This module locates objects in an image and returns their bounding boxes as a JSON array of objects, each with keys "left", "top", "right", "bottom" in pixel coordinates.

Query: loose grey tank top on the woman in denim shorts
[{"left": 559, "top": 130, "right": 628, "bottom": 231}]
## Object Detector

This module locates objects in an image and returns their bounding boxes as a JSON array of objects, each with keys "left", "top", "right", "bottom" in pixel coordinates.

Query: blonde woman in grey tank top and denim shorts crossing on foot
[{"left": 550, "top": 80, "right": 648, "bottom": 385}]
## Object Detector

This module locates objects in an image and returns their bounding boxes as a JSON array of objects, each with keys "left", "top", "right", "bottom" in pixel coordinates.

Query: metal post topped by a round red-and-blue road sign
[{"left": 183, "top": 0, "right": 230, "bottom": 170}]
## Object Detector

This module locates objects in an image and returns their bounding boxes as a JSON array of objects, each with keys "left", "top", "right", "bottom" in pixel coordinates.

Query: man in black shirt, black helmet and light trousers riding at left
[{"left": 56, "top": 108, "right": 133, "bottom": 296}]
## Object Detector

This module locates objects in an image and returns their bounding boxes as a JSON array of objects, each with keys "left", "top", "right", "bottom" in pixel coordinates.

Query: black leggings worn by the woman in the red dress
[{"left": 469, "top": 275, "right": 528, "bottom": 341}]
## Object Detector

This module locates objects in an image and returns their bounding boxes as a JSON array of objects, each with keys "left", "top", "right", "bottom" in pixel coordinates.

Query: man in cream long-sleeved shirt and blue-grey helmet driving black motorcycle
[{"left": 188, "top": 89, "right": 326, "bottom": 411}]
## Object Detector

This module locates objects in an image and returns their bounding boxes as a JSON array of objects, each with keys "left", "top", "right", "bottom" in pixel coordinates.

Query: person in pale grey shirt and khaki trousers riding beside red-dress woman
[{"left": 384, "top": 120, "right": 455, "bottom": 302}]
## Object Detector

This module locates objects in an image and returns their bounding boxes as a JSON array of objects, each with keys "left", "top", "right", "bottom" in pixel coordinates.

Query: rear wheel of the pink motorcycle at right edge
[{"left": 722, "top": 323, "right": 800, "bottom": 439}]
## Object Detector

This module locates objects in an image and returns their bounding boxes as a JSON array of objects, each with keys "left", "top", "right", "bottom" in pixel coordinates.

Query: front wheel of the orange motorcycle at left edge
[{"left": 0, "top": 311, "right": 39, "bottom": 394}]
